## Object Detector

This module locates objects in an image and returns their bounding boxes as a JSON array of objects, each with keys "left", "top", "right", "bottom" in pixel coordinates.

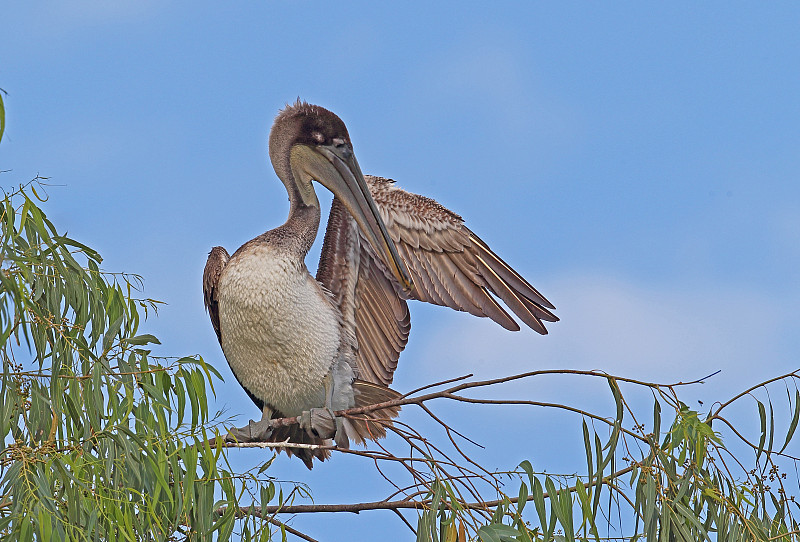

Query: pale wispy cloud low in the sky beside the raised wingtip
[{"left": 418, "top": 276, "right": 794, "bottom": 400}]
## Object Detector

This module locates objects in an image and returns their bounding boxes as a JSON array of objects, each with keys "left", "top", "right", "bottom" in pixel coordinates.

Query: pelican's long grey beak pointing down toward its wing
[{"left": 298, "top": 145, "right": 414, "bottom": 291}]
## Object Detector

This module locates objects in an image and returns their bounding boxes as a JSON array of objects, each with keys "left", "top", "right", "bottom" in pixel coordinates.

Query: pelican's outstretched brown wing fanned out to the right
[{"left": 317, "top": 175, "right": 558, "bottom": 385}]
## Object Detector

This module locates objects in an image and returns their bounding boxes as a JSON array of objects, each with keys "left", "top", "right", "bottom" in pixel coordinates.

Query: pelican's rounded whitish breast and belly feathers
[{"left": 219, "top": 243, "right": 341, "bottom": 416}]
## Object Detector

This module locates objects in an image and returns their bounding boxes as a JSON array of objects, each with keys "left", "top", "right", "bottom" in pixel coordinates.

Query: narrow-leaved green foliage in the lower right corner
[{"left": 417, "top": 372, "right": 800, "bottom": 542}]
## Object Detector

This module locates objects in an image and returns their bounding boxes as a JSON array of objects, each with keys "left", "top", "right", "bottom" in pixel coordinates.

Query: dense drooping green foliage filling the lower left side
[{"left": 0, "top": 183, "right": 288, "bottom": 541}]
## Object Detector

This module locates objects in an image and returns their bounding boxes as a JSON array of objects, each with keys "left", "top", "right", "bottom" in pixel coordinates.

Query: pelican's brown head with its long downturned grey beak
[{"left": 269, "top": 101, "right": 413, "bottom": 290}]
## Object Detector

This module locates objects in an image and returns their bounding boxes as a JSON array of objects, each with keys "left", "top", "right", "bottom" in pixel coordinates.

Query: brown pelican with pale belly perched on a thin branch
[{"left": 203, "top": 104, "right": 558, "bottom": 468}]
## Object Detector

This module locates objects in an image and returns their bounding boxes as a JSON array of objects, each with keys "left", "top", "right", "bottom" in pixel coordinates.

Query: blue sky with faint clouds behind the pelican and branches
[{"left": 0, "top": 0, "right": 800, "bottom": 540}]
